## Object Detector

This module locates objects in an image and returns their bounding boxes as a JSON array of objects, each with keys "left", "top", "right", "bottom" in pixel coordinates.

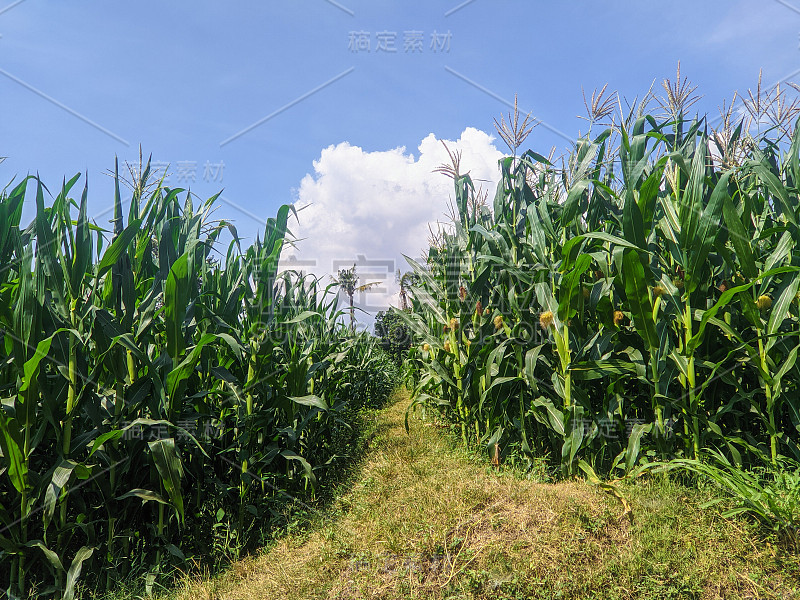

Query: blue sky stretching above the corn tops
[{"left": 0, "top": 0, "right": 800, "bottom": 318}]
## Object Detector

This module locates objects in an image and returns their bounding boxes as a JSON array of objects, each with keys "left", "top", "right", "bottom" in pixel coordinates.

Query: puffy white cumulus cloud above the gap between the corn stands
[{"left": 281, "top": 127, "right": 503, "bottom": 322}]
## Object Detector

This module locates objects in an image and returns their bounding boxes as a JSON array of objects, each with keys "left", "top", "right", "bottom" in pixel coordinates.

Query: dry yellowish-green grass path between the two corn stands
[{"left": 177, "top": 392, "right": 800, "bottom": 600}]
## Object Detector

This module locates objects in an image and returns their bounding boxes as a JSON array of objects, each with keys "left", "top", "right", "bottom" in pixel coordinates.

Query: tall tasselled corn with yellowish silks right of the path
[{"left": 399, "top": 104, "right": 800, "bottom": 474}]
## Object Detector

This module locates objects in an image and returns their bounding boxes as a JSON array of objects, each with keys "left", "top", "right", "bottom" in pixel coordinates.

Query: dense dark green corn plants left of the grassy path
[{"left": 0, "top": 157, "right": 393, "bottom": 599}]
